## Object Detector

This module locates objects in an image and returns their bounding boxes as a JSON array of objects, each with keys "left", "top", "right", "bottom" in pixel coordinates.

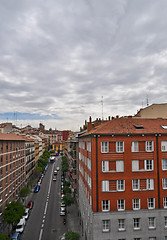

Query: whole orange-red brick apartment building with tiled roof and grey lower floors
[{"left": 79, "top": 117, "right": 167, "bottom": 240}]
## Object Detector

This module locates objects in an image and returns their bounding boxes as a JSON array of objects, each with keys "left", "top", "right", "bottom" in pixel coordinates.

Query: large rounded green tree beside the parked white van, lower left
[{"left": 3, "top": 201, "right": 25, "bottom": 227}]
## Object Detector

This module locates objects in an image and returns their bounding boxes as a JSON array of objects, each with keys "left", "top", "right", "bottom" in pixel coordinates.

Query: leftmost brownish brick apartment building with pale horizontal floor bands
[{"left": 0, "top": 133, "right": 25, "bottom": 215}]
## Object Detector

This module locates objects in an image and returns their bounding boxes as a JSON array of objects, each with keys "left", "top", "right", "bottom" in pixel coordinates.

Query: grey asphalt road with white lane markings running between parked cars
[{"left": 21, "top": 156, "right": 67, "bottom": 240}]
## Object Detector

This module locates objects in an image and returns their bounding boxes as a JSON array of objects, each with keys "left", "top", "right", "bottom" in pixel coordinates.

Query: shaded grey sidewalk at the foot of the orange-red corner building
[{"left": 67, "top": 203, "right": 84, "bottom": 240}]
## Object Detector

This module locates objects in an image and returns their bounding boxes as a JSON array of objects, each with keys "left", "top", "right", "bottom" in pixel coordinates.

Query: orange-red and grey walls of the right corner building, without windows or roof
[{"left": 79, "top": 134, "right": 167, "bottom": 240}]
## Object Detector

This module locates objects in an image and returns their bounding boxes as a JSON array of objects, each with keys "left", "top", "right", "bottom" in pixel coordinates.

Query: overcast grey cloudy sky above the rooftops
[{"left": 0, "top": 0, "right": 167, "bottom": 130}]
